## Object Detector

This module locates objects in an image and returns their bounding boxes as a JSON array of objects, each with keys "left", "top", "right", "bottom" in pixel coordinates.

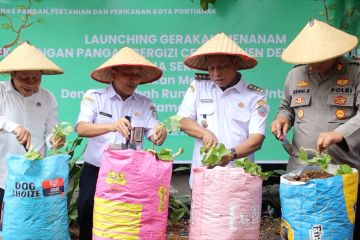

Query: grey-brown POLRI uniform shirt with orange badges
[{"left": 278, "top": 58, "right": 360, "bottom": 170}]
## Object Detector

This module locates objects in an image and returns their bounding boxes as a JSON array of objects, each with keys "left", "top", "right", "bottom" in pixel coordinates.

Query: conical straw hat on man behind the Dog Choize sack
[{"left": 0, "top": 41, "right": 64, "bottom": 74}]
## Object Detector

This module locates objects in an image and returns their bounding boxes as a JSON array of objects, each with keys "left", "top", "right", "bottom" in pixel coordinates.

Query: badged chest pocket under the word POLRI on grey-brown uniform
[{"left": 326, "top": 93, "right": 356, "bottom": 123}]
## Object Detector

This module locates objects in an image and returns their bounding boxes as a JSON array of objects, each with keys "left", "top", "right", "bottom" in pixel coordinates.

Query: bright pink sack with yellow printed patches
[{"left": 93, "top": 149, "right": 172, "bottom": 240}]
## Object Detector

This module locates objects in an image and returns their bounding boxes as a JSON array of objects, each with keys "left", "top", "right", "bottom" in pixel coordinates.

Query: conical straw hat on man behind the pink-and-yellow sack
[{"left": 91, "top": 47, "right": 162, "bottom": 84}]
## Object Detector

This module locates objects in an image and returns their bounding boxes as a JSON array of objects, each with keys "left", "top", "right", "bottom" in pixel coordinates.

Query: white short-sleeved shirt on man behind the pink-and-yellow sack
[{"left": 76, "top": 85, "right": 159, "bottom": 167}]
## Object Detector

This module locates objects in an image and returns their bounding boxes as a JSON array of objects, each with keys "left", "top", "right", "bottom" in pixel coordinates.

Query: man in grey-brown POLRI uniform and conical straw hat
[{"left": 271, "top": 20, "right": 360, "bottom": 239}]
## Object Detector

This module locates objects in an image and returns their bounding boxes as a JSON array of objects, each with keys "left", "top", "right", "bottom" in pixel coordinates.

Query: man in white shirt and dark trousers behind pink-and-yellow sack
[{"left": 75, "top": 47, "right": 166, "bottom": 240}]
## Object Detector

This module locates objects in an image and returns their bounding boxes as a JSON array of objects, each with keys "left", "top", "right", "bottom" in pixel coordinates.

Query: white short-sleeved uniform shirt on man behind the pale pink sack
[{"left": 177, "top": 75, "right": 269, "bottom": 184}]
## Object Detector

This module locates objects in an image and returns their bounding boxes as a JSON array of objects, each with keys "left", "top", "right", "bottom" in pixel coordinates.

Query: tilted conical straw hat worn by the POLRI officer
[{"left": 281, "top": 20, "right": 358, "bottom": 64}]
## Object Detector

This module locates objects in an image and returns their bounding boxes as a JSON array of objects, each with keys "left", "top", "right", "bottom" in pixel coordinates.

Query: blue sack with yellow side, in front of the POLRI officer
[{"left": 280, "top": 167, "right": 358, "bottom": 240}]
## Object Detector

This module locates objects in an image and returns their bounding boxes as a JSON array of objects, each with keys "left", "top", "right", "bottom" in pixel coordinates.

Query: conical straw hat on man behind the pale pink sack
[{"left": 184, "top": 33, "right": 257, "bottom": 70}]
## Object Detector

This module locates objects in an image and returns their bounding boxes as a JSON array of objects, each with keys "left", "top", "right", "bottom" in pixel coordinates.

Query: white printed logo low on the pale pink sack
[{"left": 229, "top": 205, "right": 261, "bottom": 229}]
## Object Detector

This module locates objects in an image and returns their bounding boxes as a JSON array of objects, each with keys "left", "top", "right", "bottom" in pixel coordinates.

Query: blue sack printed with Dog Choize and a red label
[{"left": 2, "top": 154, "right": 70, "bottom": 240}]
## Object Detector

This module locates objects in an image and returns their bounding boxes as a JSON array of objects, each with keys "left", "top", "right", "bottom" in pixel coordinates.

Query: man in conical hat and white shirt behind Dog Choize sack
[{"left": 0, "top": 42, "right": 65, "bottom": 219}]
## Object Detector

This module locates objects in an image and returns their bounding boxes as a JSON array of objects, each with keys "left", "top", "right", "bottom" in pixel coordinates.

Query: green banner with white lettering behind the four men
[{"left": 0, "top": 0, "right": 358, "bottom": 163}]
